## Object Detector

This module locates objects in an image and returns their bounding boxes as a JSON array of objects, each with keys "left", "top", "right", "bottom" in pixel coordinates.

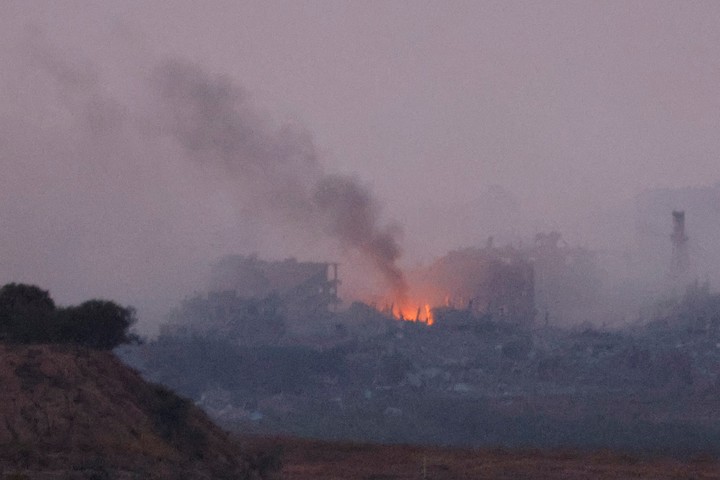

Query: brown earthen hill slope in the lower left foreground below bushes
[{"left": 0, "top": 345, "right": 258, "bottom": 479}]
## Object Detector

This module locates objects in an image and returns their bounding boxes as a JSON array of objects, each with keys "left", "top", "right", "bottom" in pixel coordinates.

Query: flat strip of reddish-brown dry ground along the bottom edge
[{"left": 246, "top": 438, "right": 720, "bottom": 480}]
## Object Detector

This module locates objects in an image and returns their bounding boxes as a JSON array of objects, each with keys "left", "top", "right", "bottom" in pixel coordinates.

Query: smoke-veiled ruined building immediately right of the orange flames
[{"left": 420, "top": 232, "right": 601, "bottom": 327}]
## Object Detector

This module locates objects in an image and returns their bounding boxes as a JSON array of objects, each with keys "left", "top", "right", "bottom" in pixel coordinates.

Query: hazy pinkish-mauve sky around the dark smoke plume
[{"left": 0, "top": 0, "right": 720, "bottom": 328}]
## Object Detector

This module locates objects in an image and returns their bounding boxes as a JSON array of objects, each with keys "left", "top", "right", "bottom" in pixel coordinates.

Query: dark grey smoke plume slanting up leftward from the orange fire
[{"left": 150, "top": 58, "right": 406, "bottom": 295}]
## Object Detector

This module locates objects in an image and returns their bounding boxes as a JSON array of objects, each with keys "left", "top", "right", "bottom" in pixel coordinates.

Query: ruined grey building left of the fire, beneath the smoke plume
[{"left": 160, "top": 255, "right": 340, "bottom": 345}]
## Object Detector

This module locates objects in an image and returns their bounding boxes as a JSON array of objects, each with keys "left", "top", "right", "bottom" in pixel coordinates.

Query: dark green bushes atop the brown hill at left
[{"left": 0, "top": 283, "right": 136, "bottom": 350}]
